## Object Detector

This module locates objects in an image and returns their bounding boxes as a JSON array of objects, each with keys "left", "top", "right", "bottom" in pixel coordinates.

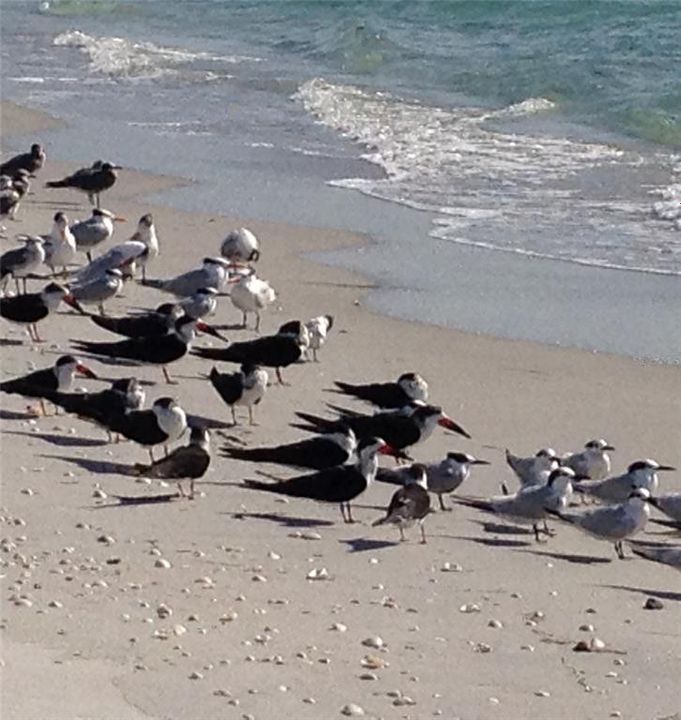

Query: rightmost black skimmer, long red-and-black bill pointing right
[{"left": 293, "top": 405, "right": 470, "bottom": 450}]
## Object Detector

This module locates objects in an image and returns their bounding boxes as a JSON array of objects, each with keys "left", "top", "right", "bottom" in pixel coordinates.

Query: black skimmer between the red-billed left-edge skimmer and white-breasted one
[{"left": 39, "top": 378, "right": 145, "bottom": 437}]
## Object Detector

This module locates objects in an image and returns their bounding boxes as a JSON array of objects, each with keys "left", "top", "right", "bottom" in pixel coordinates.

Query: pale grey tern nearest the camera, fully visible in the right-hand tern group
[{"left": 547, "top": 487, "right": 650, "bottom": 559}]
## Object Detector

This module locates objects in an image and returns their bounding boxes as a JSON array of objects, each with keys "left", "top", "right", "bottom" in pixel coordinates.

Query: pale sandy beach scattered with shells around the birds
[{"left": 0, "top": 102, "right": 681, "bottom": 720}]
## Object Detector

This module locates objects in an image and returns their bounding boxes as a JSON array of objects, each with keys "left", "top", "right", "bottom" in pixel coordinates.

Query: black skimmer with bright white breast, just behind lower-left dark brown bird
[{"left": 102, "top": 397, "right": 187, "bottom": 463}]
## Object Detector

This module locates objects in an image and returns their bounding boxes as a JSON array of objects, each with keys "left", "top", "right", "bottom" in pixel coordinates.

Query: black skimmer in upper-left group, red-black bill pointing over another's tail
[{"left": 73, "top": 316, "right": 224, "bottom": 383}]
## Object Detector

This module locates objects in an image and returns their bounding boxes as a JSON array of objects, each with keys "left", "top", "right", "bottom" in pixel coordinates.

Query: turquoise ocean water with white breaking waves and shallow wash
[{"left": 1, "top": 0, "right": 681, "bottom": 357}]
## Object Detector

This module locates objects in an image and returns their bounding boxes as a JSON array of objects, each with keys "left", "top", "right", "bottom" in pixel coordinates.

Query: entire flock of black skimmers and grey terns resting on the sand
[{"left": 0, "top": 143, "right": 681, "bottom": 570}]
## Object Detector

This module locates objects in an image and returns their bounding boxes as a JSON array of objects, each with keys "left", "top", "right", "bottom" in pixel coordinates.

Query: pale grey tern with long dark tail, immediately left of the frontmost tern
[{"left": 454, "top": 467, "right": 575, "bottom": 542}]
